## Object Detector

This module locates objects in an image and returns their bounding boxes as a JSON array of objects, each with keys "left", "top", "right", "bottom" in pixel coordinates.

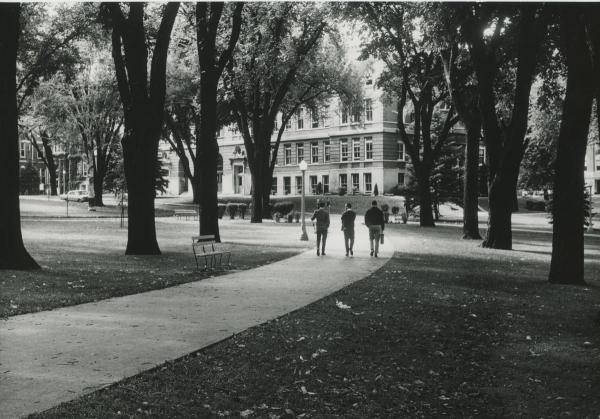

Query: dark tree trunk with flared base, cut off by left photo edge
[{"left": 0, "top": 3, "right": 40, "bottom": 269}]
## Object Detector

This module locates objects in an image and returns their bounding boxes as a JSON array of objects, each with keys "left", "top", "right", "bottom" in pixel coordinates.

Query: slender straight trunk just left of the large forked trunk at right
[{"left": 463, "top": 120, "right": 481, "bottom": 240}]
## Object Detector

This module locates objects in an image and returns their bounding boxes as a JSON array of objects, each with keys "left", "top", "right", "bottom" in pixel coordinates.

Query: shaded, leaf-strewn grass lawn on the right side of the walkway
[{"left": 35, "top": 225, "right": 600, "bottom": 418}]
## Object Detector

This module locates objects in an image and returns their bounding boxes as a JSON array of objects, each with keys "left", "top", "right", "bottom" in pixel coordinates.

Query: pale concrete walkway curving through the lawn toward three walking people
[{"left": 0, "top": 221, "right": 394, "bottom": 418}]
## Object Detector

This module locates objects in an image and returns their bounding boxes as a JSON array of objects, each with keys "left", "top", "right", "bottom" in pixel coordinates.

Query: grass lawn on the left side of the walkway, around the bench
[{"left": 0, "top": 219, "right": 300, "bottom": 317}]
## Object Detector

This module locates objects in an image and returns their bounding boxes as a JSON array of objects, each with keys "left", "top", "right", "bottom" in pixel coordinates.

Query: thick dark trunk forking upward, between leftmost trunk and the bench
[{"left": 106, "top": 2, "right": 179, "bottom": 255}]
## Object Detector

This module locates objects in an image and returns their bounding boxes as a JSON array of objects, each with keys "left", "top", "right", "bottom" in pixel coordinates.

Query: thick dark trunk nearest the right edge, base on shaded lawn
[{"left": 548, "top": 10, "right": 595, "bottom": 285}]
